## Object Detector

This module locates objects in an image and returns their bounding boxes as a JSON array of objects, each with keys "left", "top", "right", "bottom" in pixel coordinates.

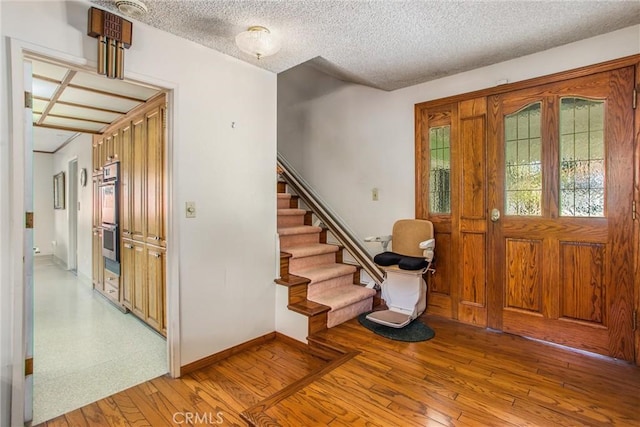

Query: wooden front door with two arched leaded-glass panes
[{"left": 488, "top": 67, "right": 634, "bottom": 360}]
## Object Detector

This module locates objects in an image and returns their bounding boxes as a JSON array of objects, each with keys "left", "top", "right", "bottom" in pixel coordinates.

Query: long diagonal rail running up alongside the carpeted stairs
[{"left": 278, "top": 153, "right": 384, "bottom": 285}]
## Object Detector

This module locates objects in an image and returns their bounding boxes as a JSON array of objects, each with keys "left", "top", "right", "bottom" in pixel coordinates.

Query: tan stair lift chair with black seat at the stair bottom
[{"left": 365, "top": 219, "right": 436, "bottom": 328}]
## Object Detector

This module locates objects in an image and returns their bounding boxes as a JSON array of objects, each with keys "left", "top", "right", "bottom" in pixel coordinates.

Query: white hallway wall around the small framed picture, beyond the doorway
[{"left": 52, "top": 134, "right": 93, "bottom": 281}]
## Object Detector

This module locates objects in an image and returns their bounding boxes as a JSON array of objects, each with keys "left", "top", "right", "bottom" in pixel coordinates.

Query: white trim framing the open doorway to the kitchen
[{"left": 7, "top": 37, "right": 180, "bottom": 425}]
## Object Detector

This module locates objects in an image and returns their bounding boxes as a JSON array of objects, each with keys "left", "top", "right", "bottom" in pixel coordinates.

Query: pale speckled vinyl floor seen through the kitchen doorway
[{"left": 33, "top": 258, "right": 167, "bottom": 425}]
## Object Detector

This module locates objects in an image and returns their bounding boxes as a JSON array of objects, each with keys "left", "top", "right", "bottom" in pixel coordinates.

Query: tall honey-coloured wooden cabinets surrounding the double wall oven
[{"left": 93, "top": 95, "right": 166, "bottom": 334}]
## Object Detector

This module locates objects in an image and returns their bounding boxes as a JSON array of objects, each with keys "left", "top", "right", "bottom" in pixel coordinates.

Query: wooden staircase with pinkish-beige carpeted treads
[{"left": 276, "top": 182, "right": 376, "bottom": 335}]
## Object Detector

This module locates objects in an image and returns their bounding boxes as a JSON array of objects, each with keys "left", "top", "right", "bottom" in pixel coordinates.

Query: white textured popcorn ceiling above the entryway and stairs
[{"left": 92, "top": 0, "right": 640, "bottom": 90}]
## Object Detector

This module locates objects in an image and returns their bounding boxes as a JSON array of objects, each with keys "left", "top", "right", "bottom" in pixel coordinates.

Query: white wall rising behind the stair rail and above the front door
[{"left": 278, "top": 26, "right": 640, "bottom": 253}]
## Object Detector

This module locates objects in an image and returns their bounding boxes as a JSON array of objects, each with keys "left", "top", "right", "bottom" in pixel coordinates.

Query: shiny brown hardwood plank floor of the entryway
[{"left": 37, "top": 316, "right": 640, "bottom": 427}]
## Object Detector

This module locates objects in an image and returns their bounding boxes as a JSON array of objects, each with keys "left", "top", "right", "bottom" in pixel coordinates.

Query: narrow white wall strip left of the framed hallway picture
[{"left": 33, "top": 153, "right": 55, "bottom": 255}]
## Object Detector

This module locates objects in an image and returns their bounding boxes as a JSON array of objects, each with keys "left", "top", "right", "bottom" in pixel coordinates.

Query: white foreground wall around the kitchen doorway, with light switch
[{"left": 0, "top": 5, "right": 276, "bottom": 425}]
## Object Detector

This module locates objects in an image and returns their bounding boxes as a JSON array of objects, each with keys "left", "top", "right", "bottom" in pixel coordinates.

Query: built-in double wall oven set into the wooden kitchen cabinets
[{"left": 100, "top": 162, "right": 120, "bottom": 262}]
